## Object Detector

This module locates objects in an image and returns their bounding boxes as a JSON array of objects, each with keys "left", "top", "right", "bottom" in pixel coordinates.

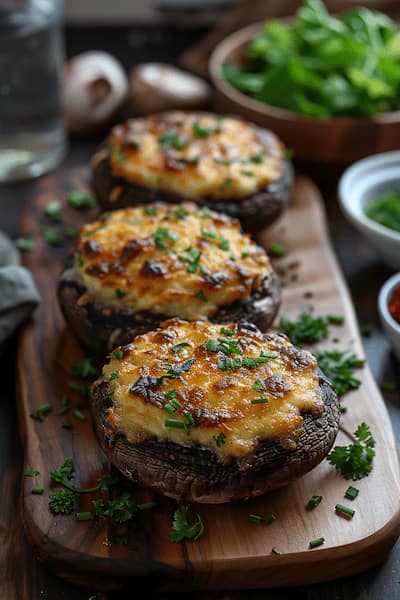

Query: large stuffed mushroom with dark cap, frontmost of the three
[{"left": 91, "top": 319, "right": 339, "bottom": 503}]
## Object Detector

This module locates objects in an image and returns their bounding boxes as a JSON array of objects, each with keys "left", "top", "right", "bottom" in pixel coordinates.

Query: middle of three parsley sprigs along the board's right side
[{"left": 314, "top": 350, "right": 365, "bottom": 395}]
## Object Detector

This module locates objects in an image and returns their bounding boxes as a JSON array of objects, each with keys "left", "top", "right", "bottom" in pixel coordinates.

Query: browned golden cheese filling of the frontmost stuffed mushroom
[{"left": 103, "top": 319, "right": 323, "bottom": 457}]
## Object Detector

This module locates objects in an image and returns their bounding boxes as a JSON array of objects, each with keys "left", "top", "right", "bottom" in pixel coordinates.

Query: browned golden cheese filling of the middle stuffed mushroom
[{"left": 70, "top": 202, "right": 272, "bottom": 320}]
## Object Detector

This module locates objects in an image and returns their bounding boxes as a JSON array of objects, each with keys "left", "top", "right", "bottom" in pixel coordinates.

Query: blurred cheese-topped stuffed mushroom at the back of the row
[{"left": 92, "top": 111, "right": 292, "bottom": 232}]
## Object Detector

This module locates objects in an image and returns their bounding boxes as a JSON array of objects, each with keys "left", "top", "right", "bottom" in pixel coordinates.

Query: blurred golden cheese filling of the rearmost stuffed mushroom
[{"left": 94, "top": 112, "right": 284, "bottom": 201}]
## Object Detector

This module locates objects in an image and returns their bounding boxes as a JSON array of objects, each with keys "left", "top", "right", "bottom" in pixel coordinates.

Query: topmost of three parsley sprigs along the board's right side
[{"left": 279, "top": 312, "right": 344, "bottom": 346}]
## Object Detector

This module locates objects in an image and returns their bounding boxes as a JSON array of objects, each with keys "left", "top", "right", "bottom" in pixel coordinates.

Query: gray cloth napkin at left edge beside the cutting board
[{"left": 0, "top": 232, "right": 40, "bottom": 354}]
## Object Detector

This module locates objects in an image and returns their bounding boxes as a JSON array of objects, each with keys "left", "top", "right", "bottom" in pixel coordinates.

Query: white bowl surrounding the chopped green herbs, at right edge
[{"left": 338, "top": 150, "right": 400, "bottom": 271}]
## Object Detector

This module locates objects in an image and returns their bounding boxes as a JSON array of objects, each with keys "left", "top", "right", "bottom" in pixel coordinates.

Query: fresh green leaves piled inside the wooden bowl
[{"left": 222, "top": 0, "right": 400, "bottom": 118}]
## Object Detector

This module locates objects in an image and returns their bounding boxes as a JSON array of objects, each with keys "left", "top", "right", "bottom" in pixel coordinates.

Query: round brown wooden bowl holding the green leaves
[{"left": 209, "top": 22, "right": 400, "bottom": 165}]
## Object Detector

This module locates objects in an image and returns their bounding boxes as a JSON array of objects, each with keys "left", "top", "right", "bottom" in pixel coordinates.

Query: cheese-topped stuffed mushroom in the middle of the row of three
[{"left": 58, "top": 202, "right": 280, "bottom": 351}]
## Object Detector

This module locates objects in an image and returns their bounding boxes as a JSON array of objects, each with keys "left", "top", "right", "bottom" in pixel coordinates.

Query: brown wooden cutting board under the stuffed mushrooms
[{"left": 17, "top": 171, "right": 400, "bottom": 590}]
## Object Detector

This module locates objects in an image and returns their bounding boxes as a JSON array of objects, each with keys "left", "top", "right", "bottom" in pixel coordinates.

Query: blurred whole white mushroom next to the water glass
[{"left": 64, "top": 50, "right": 128, "bottom": 134}]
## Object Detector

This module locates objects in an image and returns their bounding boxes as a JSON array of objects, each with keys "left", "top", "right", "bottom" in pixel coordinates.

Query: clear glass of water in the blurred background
[{"left": 0, "top": 0, "right": 66, "bottom": 182}]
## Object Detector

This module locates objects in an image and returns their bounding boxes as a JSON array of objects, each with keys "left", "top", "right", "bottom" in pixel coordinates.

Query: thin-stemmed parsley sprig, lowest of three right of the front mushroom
[{"left": 327, "top": 423, "right": 375, "bottom": 481}]
